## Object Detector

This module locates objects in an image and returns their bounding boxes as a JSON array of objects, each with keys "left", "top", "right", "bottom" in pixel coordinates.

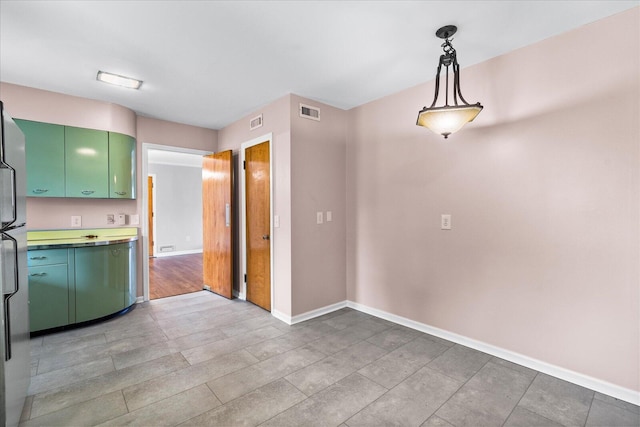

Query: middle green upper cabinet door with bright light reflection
[{"left": 64, "top": 126, "right": 109, "bottom": 198}]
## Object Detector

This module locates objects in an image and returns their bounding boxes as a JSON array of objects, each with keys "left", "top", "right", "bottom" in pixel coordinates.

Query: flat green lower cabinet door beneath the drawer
[{"left": 29, "top": 264, "right": 69, "bottom": 332}]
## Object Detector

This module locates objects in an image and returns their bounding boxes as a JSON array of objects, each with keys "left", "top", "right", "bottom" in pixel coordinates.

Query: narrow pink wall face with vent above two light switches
[{"left": 291, "top": 95, "right": 348, "bottom": 316}]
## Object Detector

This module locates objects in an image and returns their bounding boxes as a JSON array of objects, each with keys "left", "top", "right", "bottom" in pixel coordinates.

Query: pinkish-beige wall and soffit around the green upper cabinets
[{"left": 0, "top": 83, "right": 217, "bottom": 296}]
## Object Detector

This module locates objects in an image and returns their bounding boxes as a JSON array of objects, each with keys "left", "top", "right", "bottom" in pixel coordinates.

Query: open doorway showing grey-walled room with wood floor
[{"left": 141, "top": 143, "right": 209, "bottom": 301}]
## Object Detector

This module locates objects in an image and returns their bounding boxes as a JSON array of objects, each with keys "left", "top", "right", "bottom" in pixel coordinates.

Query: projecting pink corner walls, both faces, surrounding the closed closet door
[{"left": 218, "top": 95, "right": 347, "bottom": 316}]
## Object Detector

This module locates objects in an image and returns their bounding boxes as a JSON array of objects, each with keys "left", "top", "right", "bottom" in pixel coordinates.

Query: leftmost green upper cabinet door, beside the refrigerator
[{"left": 16, "top": 120, "right": 64, "bottom": 197}]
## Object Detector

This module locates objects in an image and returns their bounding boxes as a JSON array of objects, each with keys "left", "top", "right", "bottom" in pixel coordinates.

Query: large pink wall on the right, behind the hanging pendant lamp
[{"left": 347, "top": 8, "right": 640, "bottom": 390}]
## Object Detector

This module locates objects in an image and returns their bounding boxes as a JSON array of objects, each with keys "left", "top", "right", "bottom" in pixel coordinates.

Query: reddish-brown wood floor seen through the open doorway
[{"left": 149, "top": 254, "right": 203, "bottom": 299}]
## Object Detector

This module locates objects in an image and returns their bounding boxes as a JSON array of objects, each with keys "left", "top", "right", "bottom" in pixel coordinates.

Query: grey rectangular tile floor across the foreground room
[{"left": 21, "top": 292, "right": 640, "bottom": 427}]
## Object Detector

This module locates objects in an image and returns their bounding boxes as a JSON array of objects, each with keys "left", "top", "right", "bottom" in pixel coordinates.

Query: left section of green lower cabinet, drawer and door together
[{"left": 27, "top": 249, "right": 75, "bottom": 332}]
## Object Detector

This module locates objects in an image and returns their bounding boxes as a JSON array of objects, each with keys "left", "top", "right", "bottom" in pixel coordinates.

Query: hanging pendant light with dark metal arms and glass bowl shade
[{"left": 416, "top": 25, "right": 483, "bottom": 139}]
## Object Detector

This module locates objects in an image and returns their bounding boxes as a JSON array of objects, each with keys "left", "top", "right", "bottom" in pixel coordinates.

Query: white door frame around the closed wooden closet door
[{"left": 237, "top": 132, "right": 275, "bottom": 315}]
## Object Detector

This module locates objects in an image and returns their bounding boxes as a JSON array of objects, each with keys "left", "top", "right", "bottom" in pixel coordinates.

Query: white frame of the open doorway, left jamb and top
[{"left": 140, "top": 142, "right": 212, "bottom": 301}]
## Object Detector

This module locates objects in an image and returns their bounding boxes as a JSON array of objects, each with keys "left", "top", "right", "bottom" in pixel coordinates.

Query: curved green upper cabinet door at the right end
[{"left": 109, "top": 132, "right": 136, "bottom": 199}]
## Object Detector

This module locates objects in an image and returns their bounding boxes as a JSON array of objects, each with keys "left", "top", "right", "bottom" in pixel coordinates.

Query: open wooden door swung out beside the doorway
[{"left": 202, "top": 150, "right": 233, "bottom": 298}]
